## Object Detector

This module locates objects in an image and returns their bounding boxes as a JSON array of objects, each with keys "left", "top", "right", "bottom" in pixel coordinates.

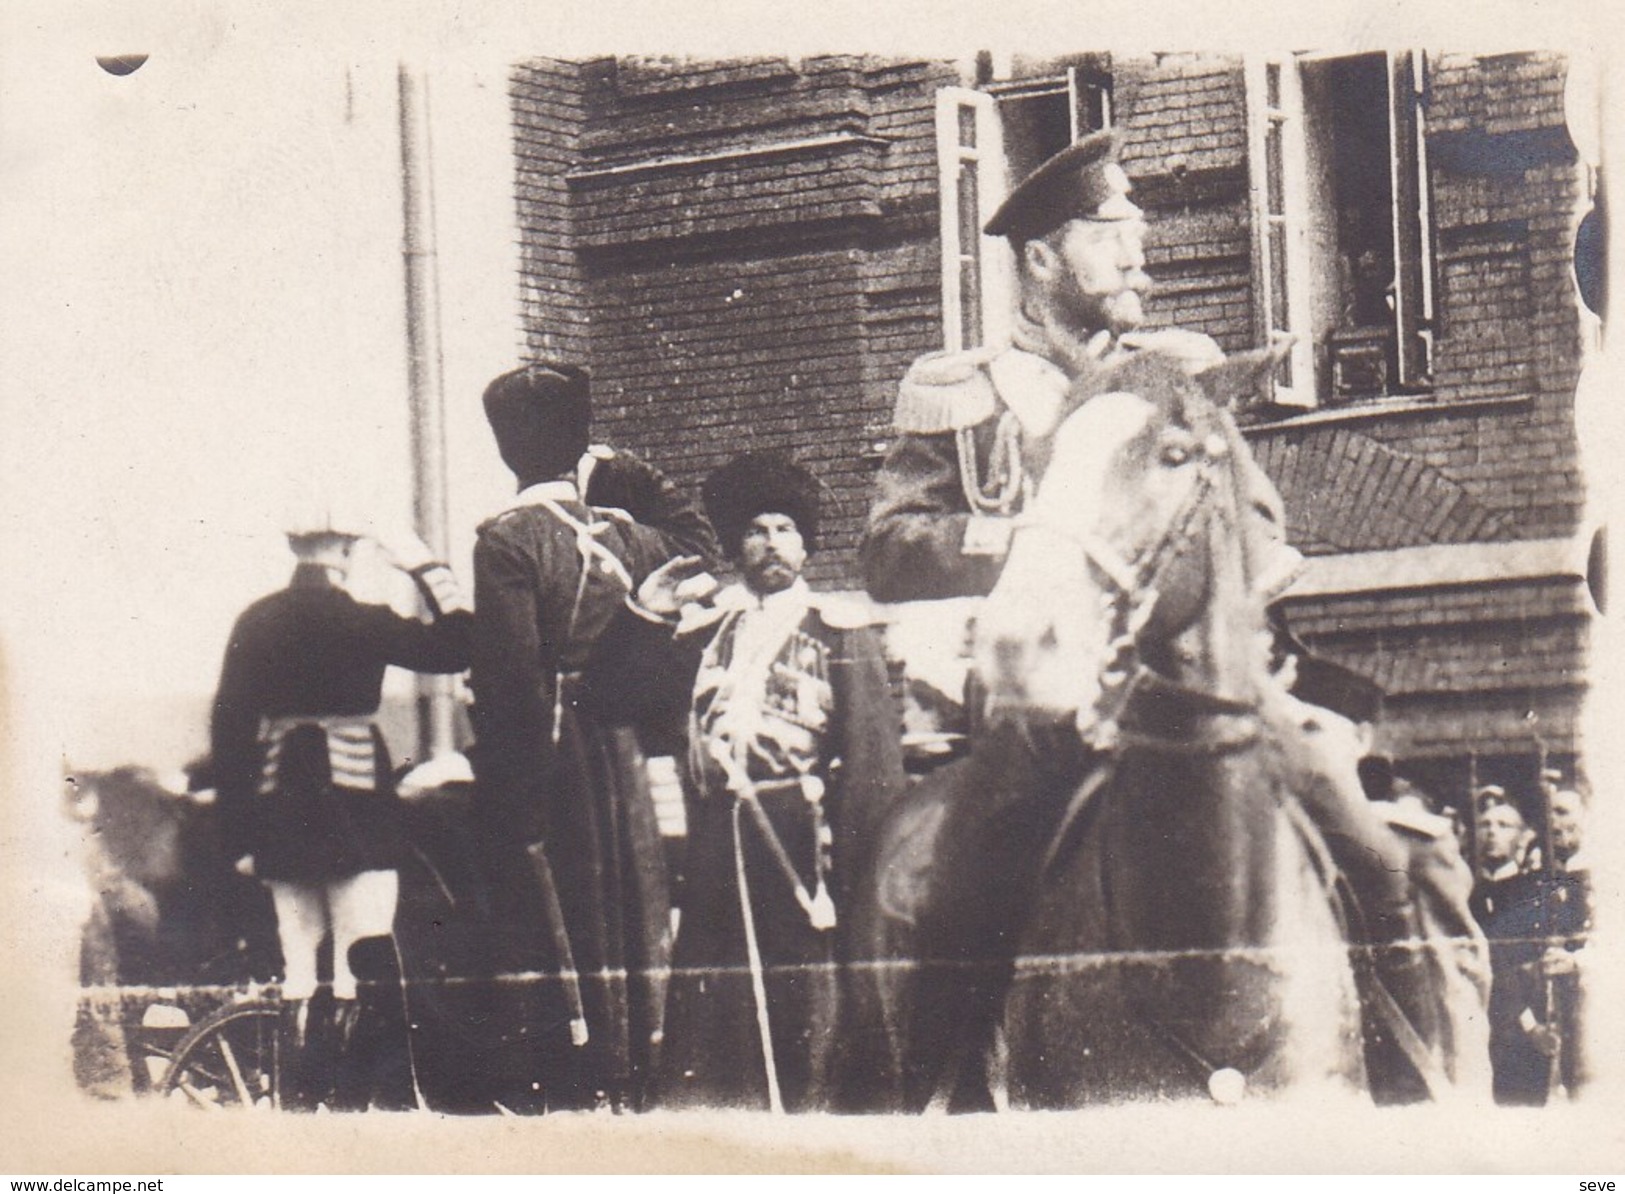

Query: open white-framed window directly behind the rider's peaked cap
[{"left": 936, "top": 67, "right": 1112, "bottom": 349}]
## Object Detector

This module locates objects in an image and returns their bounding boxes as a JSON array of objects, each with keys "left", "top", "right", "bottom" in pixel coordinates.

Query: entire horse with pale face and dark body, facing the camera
[{"left": 858, "top": 354, "right": 1391, "bottom": 1108}]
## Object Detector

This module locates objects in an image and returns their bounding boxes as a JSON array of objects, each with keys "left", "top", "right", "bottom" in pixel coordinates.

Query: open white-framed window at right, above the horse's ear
[{"left": 1246, "top": 52, "right": 1435, "bottom": 408}]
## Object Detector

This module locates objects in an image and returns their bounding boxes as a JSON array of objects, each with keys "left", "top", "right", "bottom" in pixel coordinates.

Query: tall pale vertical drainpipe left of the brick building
[{"left": 388, "top": 62, "right": 457, "bottom": 759}]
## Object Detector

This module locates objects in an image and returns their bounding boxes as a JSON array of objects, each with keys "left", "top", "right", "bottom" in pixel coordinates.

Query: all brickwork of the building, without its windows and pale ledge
[{"left": 514, "top": 54, "right": 1586, "bottom": 755}]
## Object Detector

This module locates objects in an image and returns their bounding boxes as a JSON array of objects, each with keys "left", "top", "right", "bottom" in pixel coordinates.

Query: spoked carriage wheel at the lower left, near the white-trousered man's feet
[{"left": 159, "top": 999, "right": 283, "bottom": 1110}]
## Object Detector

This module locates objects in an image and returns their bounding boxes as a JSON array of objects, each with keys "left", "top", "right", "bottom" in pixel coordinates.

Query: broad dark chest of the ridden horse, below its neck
[{"left": 1006, "top": 695, "right": 1365, "bottom": 1106}]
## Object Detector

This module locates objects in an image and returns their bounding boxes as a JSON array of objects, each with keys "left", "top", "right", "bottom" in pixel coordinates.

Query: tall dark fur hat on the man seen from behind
[{"left": 484, "top": 361, "right": 593, "bottom": 484}]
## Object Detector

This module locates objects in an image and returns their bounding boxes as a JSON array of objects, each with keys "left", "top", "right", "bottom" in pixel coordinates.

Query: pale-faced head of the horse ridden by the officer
[{"left": 977, "top": 342, "right": 1297, "bottom": 734}]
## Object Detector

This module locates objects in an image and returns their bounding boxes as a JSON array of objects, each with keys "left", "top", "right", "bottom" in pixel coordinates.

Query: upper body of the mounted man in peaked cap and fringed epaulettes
[{"left": 861, "top": 130, "right": 1297, "bottom": 749}]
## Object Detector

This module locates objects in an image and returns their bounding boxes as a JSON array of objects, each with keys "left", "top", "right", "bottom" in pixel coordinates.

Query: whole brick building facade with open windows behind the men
[{"left": 510, "top": 52, "right": 1599, "bottom": 851}]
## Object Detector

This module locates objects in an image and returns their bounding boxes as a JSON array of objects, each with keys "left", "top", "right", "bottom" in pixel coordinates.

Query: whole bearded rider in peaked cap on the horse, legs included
[{"left": 863, "top": 132, "right": 1475, "bottom": 1100}]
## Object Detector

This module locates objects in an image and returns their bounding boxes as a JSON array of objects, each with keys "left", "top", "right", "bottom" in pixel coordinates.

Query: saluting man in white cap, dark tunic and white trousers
[{"left": 211, "top": 510, "right": 473, "bottom": 1106}]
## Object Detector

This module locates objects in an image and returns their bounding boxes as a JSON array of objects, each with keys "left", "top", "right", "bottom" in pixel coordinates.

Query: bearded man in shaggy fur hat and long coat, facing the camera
[{"left": 640, "top": 453, "right": 905, "bottom": 1111}]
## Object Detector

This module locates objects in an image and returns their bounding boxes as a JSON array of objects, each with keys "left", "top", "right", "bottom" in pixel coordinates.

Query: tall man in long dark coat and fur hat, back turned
[{"left": 470, "top": 364, "right": 710, "bottom": 1110}]
